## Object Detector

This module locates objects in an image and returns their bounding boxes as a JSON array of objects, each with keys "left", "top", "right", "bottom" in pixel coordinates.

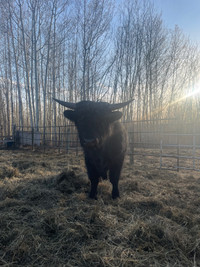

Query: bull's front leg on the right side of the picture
[{"left": 109, "top": 161, "right": 123, "bottom": 199}]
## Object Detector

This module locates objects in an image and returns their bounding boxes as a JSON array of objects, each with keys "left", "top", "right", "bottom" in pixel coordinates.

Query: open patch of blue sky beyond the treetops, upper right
[{"left": 152, "top": 0, "right": 200, "bottom": 45}]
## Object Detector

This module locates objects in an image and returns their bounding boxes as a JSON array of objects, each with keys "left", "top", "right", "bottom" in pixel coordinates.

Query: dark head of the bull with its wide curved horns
[{"left": 54, "top": 98, "right": 133, "bottom": 148}]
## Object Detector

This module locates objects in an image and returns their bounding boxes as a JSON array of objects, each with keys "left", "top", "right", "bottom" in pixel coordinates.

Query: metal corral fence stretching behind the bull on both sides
[{"left": 0, "top": 118, "right": 200, "bottom": 171}]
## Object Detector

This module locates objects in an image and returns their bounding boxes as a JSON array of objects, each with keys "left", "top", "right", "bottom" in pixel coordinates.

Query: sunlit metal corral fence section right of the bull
[{"left": 126, "top": 118, "right": 200, "bottom": 171}]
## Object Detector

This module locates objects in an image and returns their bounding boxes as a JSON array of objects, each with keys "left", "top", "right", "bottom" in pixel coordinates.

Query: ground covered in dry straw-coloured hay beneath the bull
[{"left": 0, "top": 150, "right": 200, "bottom": 267}]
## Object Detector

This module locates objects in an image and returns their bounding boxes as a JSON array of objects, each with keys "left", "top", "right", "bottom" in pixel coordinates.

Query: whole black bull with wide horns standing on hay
[{"left": 54, "top": 99, "right": 132, "bottom": 199}]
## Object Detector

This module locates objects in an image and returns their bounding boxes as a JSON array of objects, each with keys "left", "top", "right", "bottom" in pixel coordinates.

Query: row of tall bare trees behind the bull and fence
[{"left": 0, "top": 0, "right": 200, "bottom": 138}]
